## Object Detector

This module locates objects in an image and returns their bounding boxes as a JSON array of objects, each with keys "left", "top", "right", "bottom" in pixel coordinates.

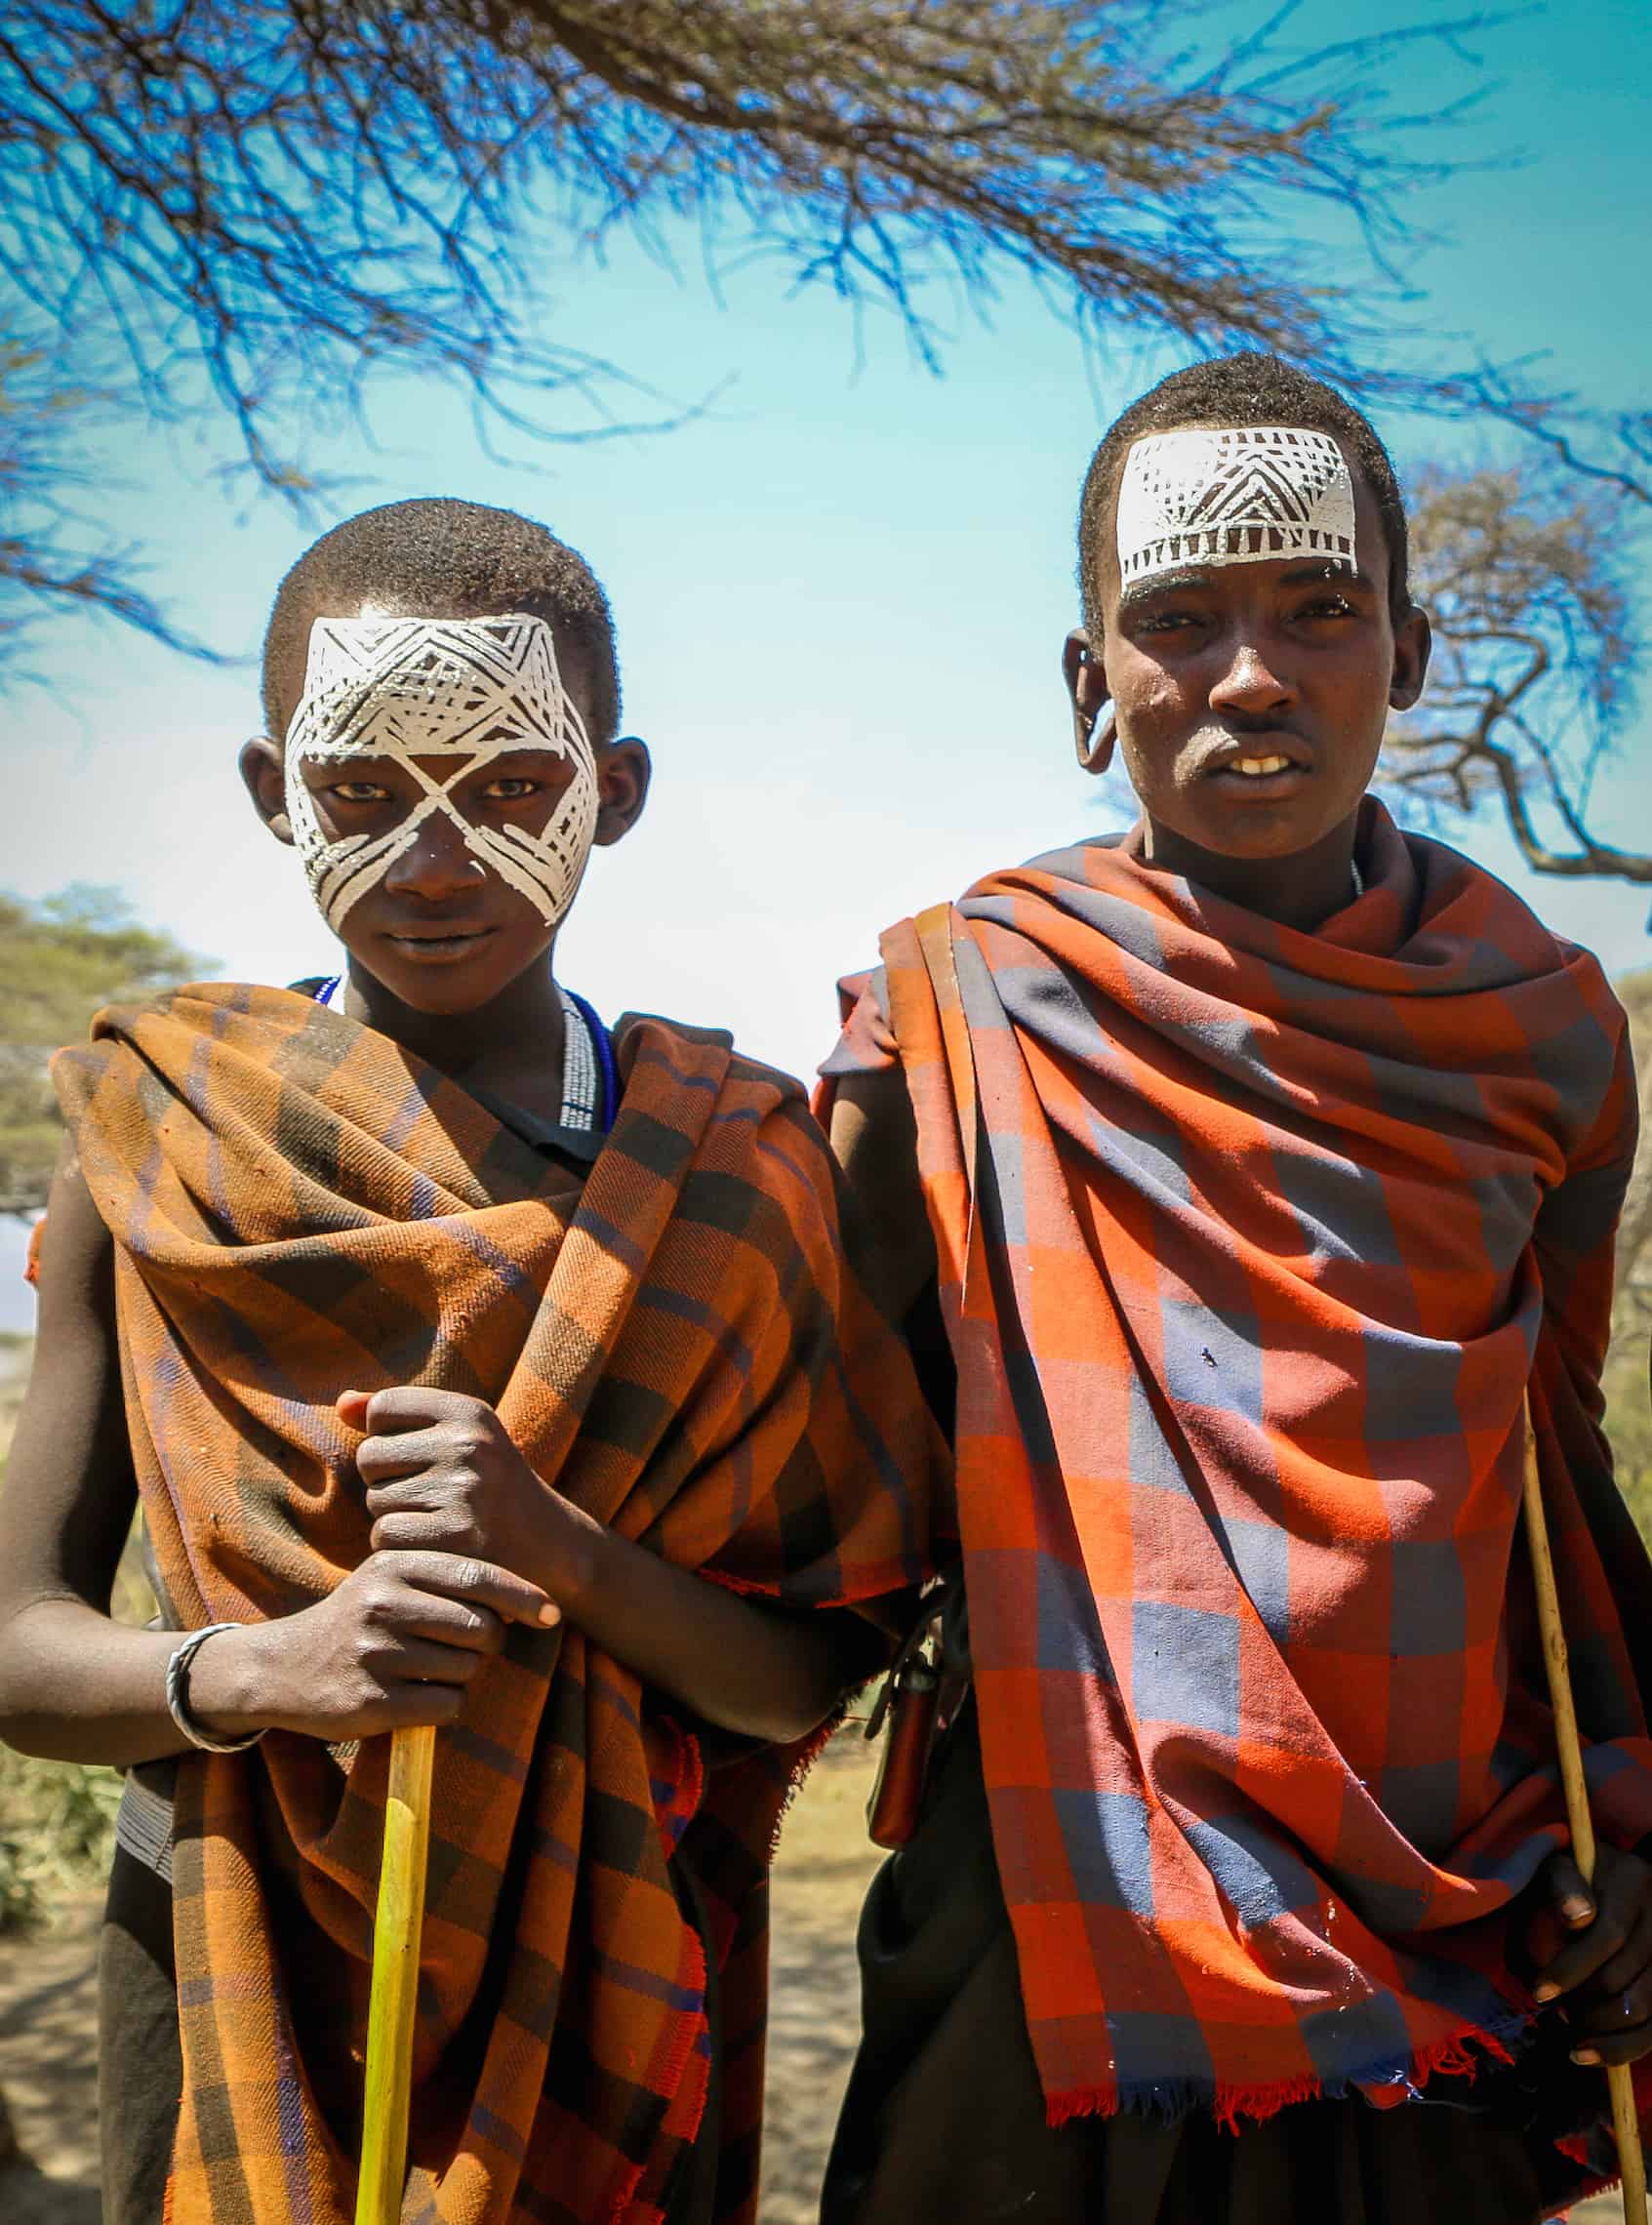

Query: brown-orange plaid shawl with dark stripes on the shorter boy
[{"left": 56, "top": 986, "right": 929, "bottom": 2225}]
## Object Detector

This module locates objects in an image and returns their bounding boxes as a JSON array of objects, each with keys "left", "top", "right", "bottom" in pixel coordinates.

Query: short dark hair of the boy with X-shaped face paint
[{"left": 264, "top": 494, "right": 621, "bottom": 746}]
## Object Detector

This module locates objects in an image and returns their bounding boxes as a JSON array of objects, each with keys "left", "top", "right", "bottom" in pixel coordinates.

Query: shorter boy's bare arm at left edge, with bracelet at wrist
[{"left": 0, "top": 1146, "right": 553, "bottom": 1764}]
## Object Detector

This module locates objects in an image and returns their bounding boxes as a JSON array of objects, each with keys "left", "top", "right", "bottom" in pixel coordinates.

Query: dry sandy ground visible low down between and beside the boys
[{"left": 0, "top": 1729, "right": 1621, "bottom": 2225}]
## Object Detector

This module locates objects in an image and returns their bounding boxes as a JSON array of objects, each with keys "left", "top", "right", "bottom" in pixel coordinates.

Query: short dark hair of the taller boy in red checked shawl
[{"left": 1078, "top": 349, "right": 1412, "bottom": 641}]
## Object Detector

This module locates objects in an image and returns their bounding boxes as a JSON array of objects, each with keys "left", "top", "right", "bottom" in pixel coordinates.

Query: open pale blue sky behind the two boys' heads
[{"left": 0, "top": 0, "right": 1652, "bottom": 1324}]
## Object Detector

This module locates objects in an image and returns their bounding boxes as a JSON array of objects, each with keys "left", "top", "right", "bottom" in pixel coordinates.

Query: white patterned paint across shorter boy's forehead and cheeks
[{"left": 287, "top": 614, "right": 598, "bottom": 932}]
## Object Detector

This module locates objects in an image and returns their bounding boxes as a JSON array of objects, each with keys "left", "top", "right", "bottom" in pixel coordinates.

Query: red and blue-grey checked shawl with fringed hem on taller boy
[{"left": 825, "top": 803, "right": 1652, "bottom": 2123}]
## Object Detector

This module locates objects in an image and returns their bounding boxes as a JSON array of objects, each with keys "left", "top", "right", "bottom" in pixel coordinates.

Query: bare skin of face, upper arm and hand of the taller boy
[{"left": 831, "top": 429, "right": 1652, "bottom": 2063}]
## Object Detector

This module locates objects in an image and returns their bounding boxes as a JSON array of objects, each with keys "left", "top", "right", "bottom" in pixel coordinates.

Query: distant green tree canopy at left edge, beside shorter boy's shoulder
[{"left": 0, "top": 888, "right": 211, "bottom": 1213}]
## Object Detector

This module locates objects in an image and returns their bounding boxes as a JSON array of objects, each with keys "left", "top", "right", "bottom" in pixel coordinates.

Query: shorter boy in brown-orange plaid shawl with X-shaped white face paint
[{"left": 0, "top": 501, "right": 934, "bottom": 2225}]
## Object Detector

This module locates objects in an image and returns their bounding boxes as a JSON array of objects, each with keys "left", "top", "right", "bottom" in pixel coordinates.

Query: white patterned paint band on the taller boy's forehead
[{"left": 1118, "top": 425, "right": 1354, "bottom": 587}]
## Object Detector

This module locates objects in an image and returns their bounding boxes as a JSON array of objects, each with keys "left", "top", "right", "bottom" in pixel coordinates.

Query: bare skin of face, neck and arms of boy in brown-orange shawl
[{"left": 0, "top": 603, "right": 880, "bottom": 1764}]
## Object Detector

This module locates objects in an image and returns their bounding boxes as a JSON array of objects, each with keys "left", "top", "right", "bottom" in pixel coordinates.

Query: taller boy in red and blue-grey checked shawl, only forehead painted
[{"left": 823, "top": 356, "right": 1652, "bottom": 2225}]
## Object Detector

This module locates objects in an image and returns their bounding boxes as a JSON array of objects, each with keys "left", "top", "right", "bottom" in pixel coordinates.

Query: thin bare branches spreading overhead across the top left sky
[{"left": 0, "top": 0, "right": 1452, "bottom": 647}]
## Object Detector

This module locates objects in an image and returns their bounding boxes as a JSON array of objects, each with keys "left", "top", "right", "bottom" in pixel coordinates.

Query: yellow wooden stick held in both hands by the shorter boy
[{"left": 356, "top": 1726, "right": 436, "bottom": 2225}]
